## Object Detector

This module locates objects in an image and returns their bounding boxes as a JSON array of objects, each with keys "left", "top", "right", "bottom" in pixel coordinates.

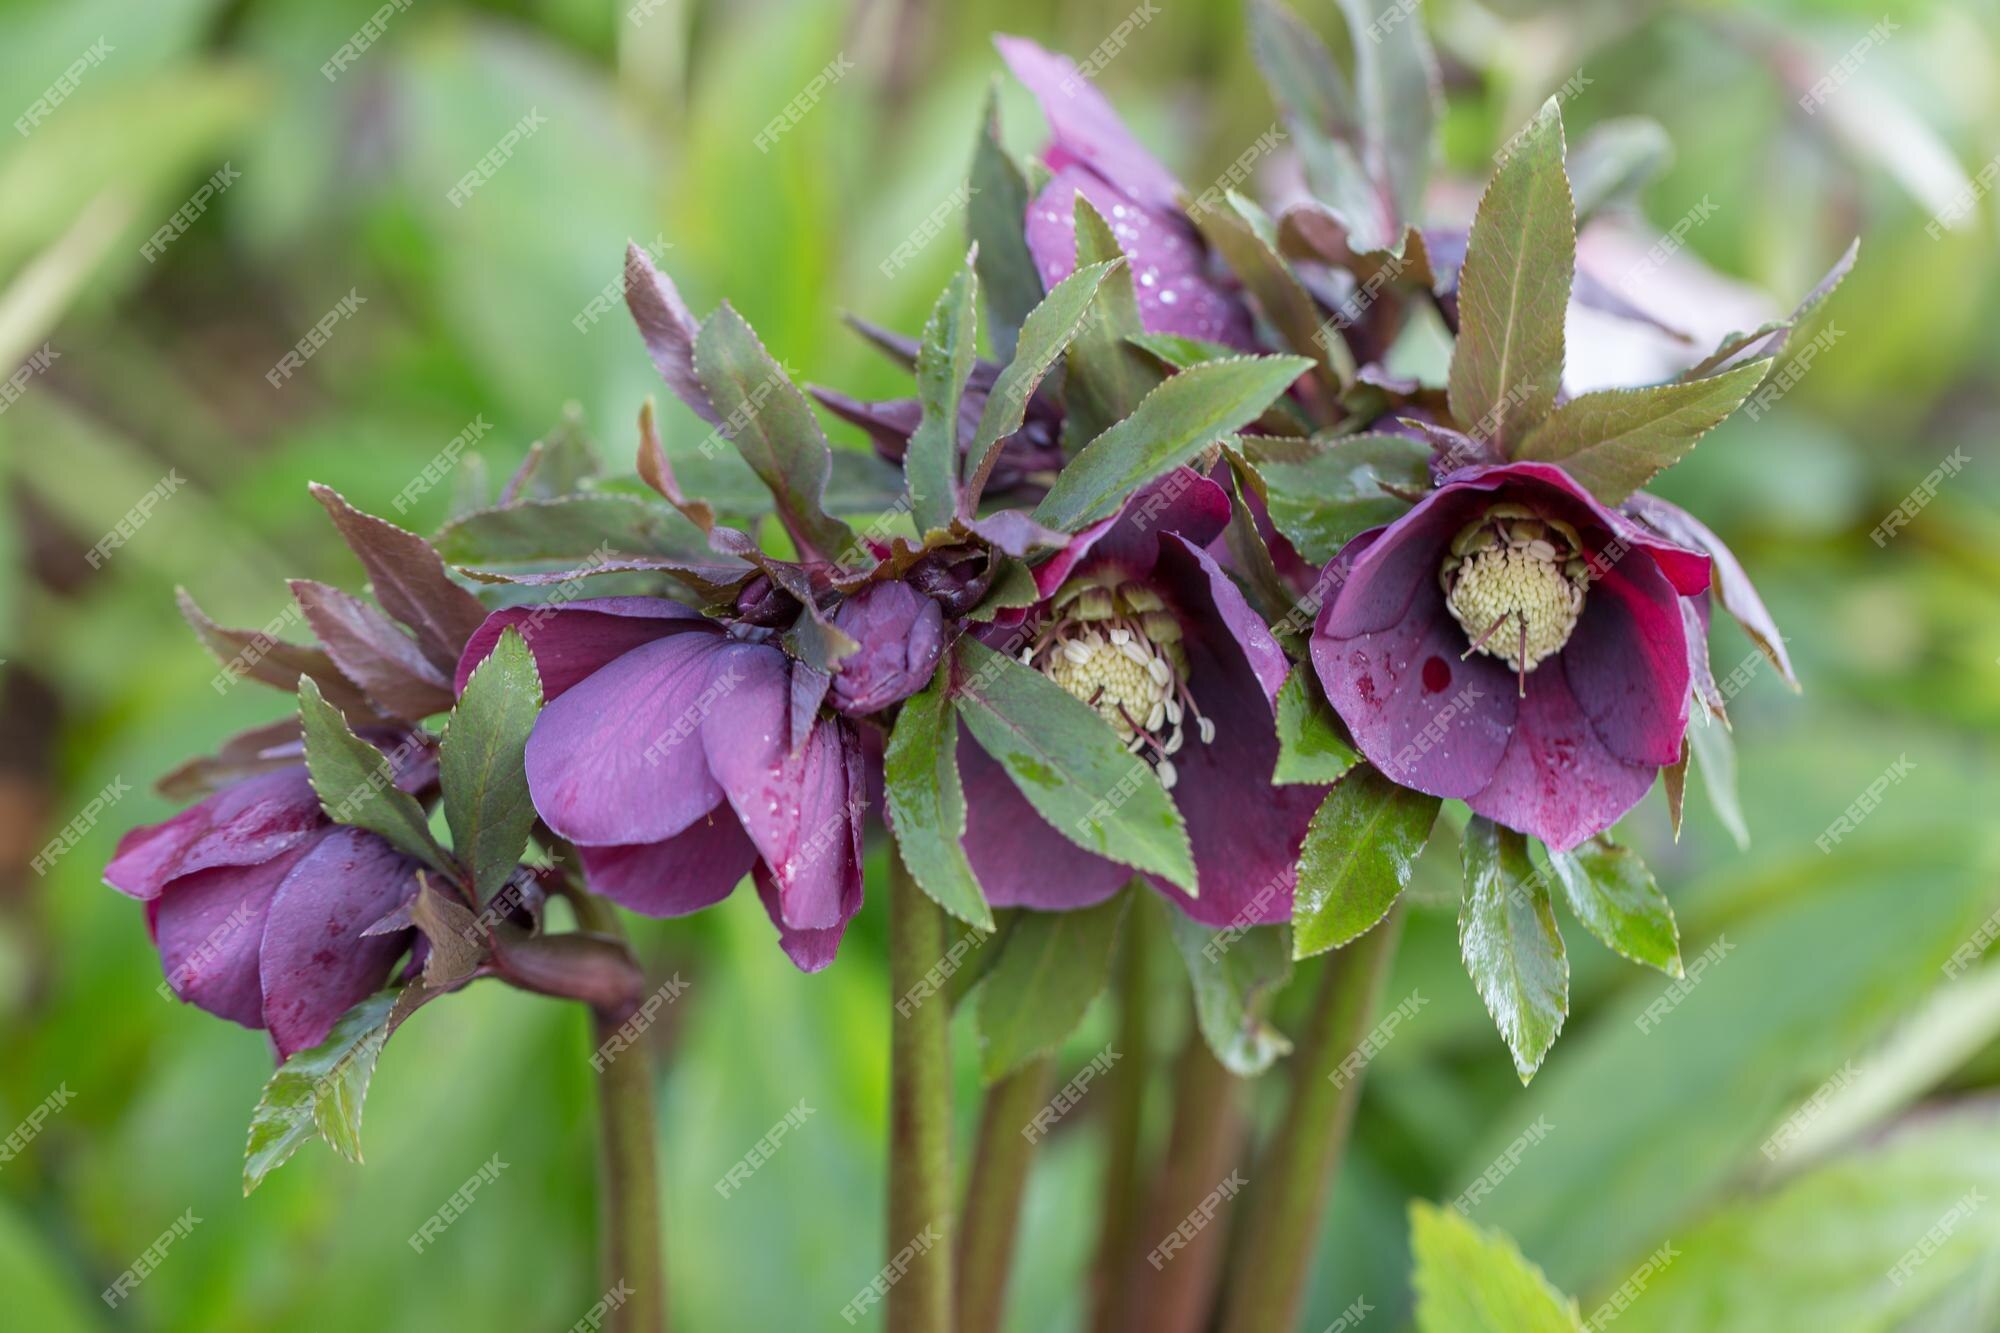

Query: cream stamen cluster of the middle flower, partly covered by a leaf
[{"left": 1020, "top": 566, "right": 1216, "bottom": 787}]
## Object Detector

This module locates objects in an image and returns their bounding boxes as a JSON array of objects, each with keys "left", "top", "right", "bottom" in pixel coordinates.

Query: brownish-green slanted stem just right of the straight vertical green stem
[{"left": 954, "top": 1055, "right": 1056, "bottom": 1333}]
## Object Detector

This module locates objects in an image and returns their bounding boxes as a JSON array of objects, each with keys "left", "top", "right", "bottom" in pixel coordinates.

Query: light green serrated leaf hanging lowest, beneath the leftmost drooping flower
[{"left": 244, "top": 991, "right": 398, "bottom": 1195}]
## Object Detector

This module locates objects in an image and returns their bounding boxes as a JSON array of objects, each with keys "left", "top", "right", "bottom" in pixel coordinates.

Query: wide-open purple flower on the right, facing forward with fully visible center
[{"left": 1312, "top": 462, "right": 1708, "bottom": 851}]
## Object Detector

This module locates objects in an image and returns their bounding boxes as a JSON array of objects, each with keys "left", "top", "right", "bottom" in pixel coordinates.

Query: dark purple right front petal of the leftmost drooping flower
[{"left": 258, "top": 829, "right": 416, "bottom": 1059}]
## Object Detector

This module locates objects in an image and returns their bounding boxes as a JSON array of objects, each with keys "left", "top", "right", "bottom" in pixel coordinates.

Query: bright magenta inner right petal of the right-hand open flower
[{"left": 1560, "top": 560, "right": 1690, "bottom": 769}]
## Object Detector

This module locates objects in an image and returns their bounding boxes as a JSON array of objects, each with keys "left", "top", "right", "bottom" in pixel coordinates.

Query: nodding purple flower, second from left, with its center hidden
[{"left": 456, "top": 596, "right": 868, "bottom": 971}]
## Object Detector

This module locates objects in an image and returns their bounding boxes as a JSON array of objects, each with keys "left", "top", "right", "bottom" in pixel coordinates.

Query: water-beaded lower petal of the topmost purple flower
[{"left": 1026, "top": 166, "right": 1254, "bottom": 348}]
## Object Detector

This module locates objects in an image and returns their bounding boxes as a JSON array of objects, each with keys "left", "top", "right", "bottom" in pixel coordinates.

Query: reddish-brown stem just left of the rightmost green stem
[{"left": 1124, "top": 1013, "right": 1244, "bottom": 1333}]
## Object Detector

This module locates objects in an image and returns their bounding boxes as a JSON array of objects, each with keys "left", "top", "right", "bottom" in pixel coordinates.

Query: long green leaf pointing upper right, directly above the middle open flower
[{"left": 1034, "top": 356, "right": 1312, "bottom": 532}]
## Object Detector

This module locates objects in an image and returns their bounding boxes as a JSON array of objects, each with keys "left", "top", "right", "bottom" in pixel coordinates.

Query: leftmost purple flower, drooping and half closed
[{"left": 104, "top": 755, "right": 436, "bottom": 1059}]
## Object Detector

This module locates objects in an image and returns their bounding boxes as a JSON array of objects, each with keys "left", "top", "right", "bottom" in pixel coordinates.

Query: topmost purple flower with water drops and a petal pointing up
[{"left": 994, "top": 36, "right": 1254, "bottom": 348}]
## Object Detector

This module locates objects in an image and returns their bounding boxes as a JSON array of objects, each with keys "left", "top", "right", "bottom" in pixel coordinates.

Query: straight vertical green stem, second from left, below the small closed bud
[{"left": 888, "top": 857, "right": 952, "bottom": 1333}]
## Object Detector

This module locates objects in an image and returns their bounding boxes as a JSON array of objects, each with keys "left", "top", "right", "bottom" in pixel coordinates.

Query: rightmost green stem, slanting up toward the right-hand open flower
[{"left": 1222, "top": 911, "right": 1402, "bottom": 1333}]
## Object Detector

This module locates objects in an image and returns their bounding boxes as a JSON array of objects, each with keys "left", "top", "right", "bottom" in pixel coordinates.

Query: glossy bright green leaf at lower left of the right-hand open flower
[{"left": 1292, "top": 765, "right": 1440, "bottom": 959}]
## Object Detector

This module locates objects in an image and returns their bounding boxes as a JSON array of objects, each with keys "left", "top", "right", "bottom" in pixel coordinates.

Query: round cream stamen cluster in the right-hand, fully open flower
[{"left": 1438, "top": 504, "right": 1588, "bottom": 693}]
